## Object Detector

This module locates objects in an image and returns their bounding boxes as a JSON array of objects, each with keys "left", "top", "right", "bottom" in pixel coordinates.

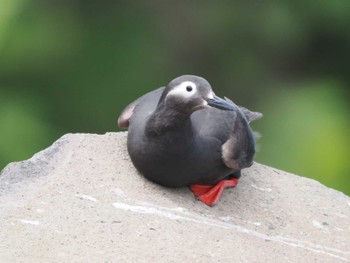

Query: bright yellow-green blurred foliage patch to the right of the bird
[{"left": 256, "top": 81, "right": 350, "bottom": 195}]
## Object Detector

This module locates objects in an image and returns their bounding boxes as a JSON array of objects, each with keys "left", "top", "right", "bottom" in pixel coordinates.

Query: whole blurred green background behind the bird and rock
[{"left": 0, "top": 0, "right": 350, "bottom": 195}]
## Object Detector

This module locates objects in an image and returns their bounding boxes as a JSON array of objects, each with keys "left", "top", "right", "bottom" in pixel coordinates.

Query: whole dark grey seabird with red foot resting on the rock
[{"left": 118, "top": 75, "right": 262, "bottom": 205}]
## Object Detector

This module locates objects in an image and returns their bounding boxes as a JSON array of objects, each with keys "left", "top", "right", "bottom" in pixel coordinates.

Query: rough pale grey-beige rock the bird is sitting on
[{"left": 0, "top": 133, "right": 350, "bottom": 262}]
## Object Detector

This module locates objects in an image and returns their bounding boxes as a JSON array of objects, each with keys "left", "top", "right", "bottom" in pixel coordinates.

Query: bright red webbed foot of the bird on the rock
[{"left": 190, "top": 178, "right": 238, "bottom": 206}]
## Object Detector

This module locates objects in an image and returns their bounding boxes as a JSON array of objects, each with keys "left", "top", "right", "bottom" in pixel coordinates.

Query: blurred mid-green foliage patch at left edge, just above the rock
[{"left": 0, "top": 93, "right": 58, "bottom": 167}]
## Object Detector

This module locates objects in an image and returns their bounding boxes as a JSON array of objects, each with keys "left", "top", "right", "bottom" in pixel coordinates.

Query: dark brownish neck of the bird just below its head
[{"left": 146, "top": 104, "right": 192, "bottom": 137}]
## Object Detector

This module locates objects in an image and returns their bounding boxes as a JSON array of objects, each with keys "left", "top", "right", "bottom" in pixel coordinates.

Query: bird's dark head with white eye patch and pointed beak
[{"left": 160, "top": 75, "right": 235, "bottom": 114}]
